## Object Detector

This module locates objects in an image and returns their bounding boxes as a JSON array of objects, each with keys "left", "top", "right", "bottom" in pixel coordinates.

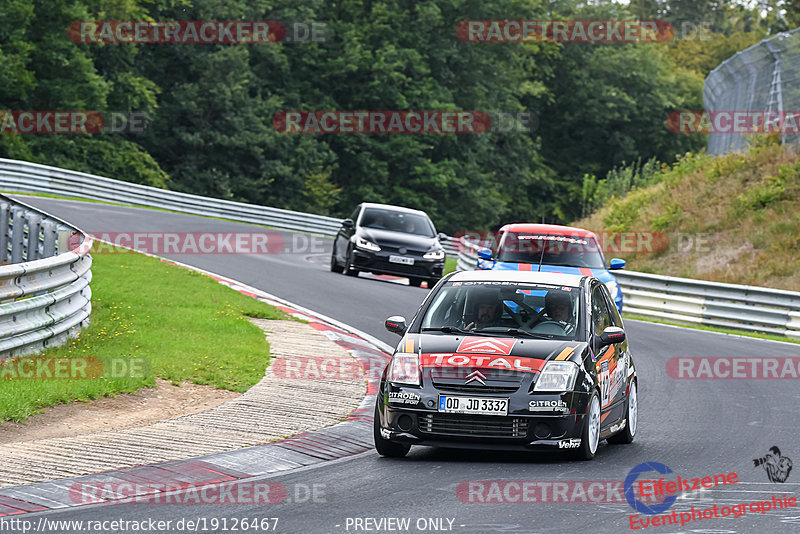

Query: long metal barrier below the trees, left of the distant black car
[{"left": 0, "top": 159, "right": 462, "bottom": 255}]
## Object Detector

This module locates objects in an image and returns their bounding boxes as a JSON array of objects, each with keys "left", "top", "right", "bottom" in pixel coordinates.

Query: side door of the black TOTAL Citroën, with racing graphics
[{"left": 591, "top": 282, "right": 627, "bottom": 427}]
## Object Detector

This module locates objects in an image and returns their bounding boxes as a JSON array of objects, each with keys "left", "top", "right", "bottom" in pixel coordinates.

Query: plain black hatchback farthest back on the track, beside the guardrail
[{"left": 331, "top": 203, "right": 446, "bottom": 287}]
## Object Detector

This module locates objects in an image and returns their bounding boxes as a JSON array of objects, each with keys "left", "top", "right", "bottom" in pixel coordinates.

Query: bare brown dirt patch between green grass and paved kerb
[{"left": 0, "top": 379, "right": 240, "bottom": 444}]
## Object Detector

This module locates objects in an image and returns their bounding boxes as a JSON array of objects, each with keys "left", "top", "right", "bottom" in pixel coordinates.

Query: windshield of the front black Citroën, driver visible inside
[{"left": 422, "top": 282, "right": 580, "bottom": 339}]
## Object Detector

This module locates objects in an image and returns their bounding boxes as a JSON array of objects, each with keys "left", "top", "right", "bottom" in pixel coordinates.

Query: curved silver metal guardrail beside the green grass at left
[{"left": 0, "top": 195, "right": 92, "bottom": 360}]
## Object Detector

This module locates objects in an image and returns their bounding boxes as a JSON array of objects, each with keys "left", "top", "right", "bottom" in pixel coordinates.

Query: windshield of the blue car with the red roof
[{"left": 497, "top": 232, "right": 605, "bottom": 269}]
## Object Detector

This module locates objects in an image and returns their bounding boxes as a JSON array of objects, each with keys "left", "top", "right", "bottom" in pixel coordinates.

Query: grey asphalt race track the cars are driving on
[{"left": 6, "top": 197, "right": 800, "bottom": 533}]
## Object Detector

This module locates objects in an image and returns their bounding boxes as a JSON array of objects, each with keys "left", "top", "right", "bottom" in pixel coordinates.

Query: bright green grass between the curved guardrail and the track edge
[{"left": 0, "top": 245, "right": 286, "bottom": 421}]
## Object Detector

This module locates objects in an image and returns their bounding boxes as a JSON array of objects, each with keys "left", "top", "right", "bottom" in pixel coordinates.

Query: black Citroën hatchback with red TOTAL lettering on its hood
[{"left": 374, "top": 271, "right": 638, "bottom": 460}]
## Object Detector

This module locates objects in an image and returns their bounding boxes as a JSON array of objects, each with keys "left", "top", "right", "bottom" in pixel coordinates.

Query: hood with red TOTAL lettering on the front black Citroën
[{"left": 406, "top": 334, "right": 586, "bottom": 372}]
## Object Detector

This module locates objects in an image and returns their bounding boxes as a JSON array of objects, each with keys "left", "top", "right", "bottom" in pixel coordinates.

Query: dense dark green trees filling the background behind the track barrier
[{"left": 0, "top": 0, "right": 791, "bottom": 233}]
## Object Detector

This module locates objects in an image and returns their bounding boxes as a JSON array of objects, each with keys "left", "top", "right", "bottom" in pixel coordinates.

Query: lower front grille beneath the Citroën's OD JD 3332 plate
[{"left": 419, "top": 413, "right": 528, "bottom": 438}]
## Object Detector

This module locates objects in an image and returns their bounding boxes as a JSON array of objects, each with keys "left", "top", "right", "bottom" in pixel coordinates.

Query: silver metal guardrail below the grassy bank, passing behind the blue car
[{"left": 457, "top": 242, "right": 800, "bottom": 338}]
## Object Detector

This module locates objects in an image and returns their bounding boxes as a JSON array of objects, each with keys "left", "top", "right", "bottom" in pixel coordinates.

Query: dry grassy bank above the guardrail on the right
[{"left": 574, "top": 142, "right": 800, "bottom": 291}]
